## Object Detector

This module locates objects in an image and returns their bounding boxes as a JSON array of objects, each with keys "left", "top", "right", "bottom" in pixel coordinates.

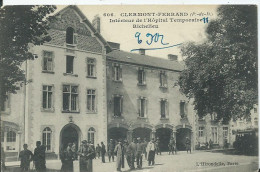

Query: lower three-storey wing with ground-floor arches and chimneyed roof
[{"left": 107, "top": 49, "right": 195, "bottom": 150}]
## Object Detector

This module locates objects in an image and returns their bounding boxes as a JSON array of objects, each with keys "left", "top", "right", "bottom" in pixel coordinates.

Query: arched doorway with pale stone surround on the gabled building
[{"left": 60, "top": 124, "right": 81, "bottom": 149}]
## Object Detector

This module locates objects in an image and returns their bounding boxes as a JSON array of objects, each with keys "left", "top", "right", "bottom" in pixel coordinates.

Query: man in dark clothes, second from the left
[{"left": 33, "top": 141, "right": 46, "bottom": 172}]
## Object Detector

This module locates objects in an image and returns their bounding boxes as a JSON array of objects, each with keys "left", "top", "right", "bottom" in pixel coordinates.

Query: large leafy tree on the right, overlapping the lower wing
[{"left": 179, "top": 5, "right": 258, "bottom": 122}]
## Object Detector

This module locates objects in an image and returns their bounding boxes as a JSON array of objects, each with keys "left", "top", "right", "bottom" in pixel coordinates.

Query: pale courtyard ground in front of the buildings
[{"left": 4, "top": 151, "right": 258, "bottom": 172}]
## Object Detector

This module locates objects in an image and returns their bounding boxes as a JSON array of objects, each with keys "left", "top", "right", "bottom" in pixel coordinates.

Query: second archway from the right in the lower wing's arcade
[{"left": 155, "top": 128, "right": 172, "bottom": 151}]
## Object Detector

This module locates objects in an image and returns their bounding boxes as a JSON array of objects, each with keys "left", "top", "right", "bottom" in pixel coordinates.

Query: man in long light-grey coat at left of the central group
[{"left": 114, "top": 139, "right": 125, "bottom": 171}]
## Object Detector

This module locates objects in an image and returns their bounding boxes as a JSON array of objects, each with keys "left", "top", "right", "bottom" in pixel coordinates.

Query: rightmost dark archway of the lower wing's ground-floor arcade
[{"left": 176, "top": 128, "right": 191, "bottom": 151}]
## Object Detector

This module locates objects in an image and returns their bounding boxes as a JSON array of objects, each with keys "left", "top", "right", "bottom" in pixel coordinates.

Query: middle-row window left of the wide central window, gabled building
[{"left": 42, "top": 85, "right": 53, "bottom": 109}]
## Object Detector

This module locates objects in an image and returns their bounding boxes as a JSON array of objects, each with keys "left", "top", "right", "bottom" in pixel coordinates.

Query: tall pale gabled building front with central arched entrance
[{"left": 1, "top": 6, "right": 111, "bottom": 156}]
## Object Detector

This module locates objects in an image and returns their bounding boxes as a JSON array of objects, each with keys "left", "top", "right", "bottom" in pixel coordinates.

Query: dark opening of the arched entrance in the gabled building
[{"left": 61, "top": 125, "right": 79, "bottom": 148}]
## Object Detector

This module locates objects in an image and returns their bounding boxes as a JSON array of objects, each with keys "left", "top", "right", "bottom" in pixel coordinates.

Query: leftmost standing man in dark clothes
[{"left": 19, "top": 144, "right": 33, "bottom": 171}]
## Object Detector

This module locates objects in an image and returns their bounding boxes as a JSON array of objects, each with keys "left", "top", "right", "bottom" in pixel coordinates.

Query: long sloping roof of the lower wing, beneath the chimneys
[{"left": 107, "top": 50, "right": 184, "bottom": 71}]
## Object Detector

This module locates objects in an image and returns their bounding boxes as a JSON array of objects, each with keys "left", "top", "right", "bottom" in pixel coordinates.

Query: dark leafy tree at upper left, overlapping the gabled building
[{"left": 0, "top": 6, "right": 56, "bottom": 106}]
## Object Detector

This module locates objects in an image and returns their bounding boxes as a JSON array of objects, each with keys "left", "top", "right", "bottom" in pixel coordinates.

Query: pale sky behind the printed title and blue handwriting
[{"left": 57, "top": 5, "right": 218, "bottom": 60}]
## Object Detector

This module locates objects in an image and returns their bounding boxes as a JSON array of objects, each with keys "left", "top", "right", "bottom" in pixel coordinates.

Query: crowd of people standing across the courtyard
[{"left": 1, "top": 137, "right": 191, "bottom": 172}]
